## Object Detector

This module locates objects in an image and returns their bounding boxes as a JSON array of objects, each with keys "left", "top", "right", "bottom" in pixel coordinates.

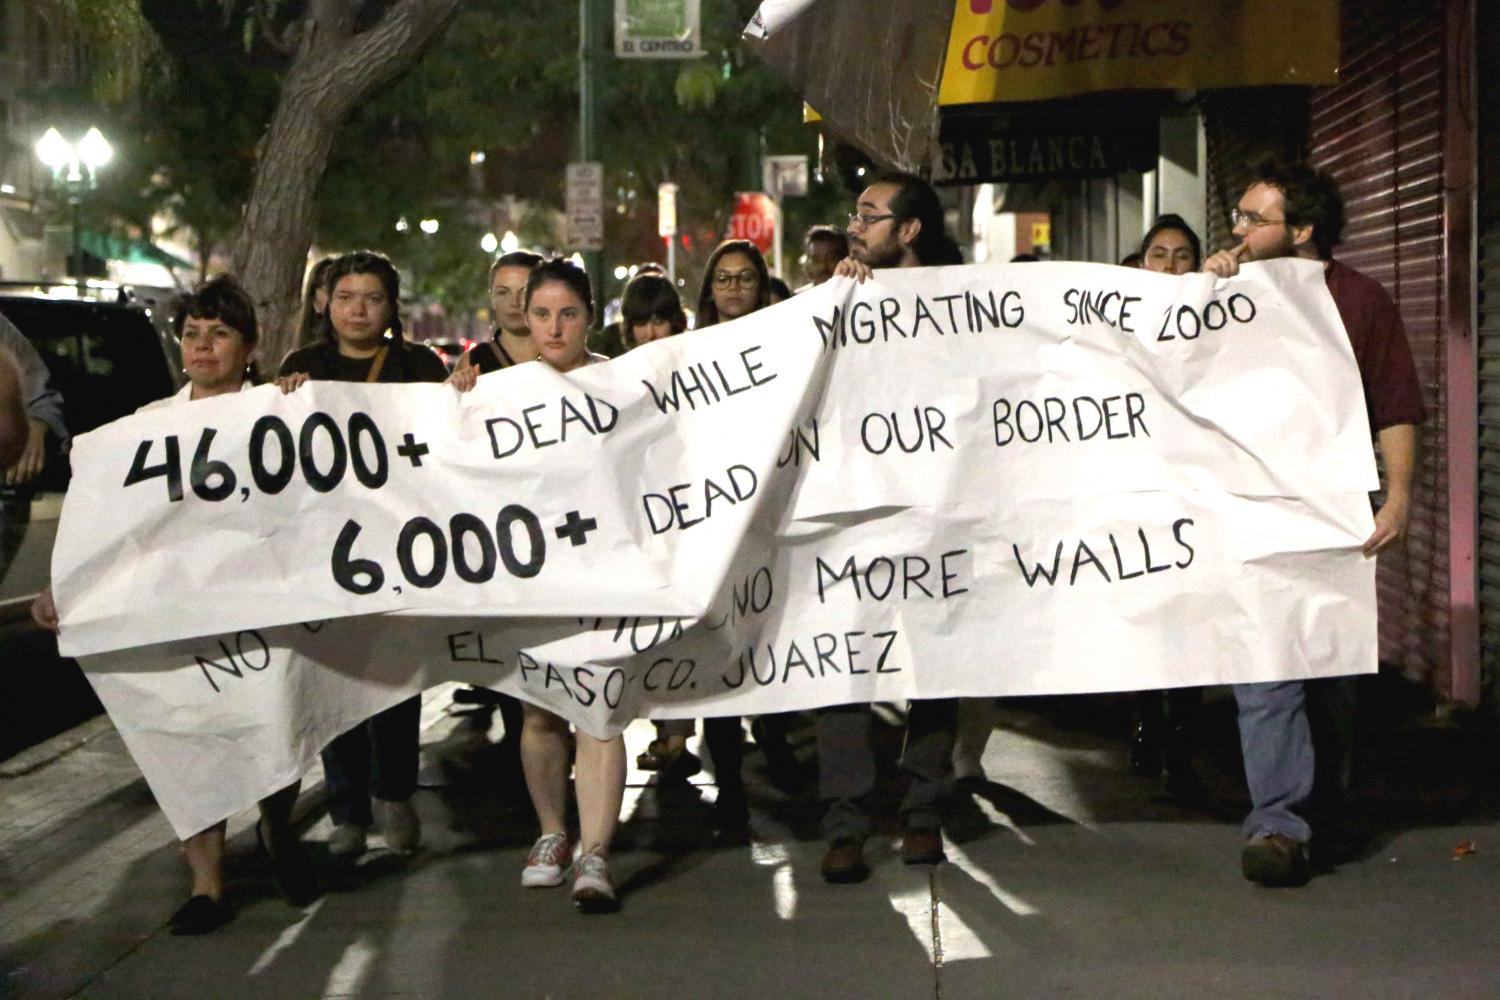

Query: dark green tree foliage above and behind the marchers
[{"left": 58, "top": 0, "right": 848, "bottom": 308}]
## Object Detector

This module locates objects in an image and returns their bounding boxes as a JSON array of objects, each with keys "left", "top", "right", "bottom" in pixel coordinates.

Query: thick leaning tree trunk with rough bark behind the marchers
[{"left": 231, "top": 0, "right": 459, "bottom": 372}]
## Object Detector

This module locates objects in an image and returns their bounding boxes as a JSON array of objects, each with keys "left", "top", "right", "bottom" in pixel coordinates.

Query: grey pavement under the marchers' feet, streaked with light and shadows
[{"left": 0, "top": 688, "right": 1500, "bottom": 1000}]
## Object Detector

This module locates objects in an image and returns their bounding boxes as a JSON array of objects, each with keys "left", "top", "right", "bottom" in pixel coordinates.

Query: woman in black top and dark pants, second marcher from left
[{"left": 276, "top": 250, "right": 449, "bottom": 858}]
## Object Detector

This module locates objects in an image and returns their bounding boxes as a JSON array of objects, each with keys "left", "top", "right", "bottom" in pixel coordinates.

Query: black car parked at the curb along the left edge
[{"left": 0, "top": 288, "right": 182, "bottom": 759}]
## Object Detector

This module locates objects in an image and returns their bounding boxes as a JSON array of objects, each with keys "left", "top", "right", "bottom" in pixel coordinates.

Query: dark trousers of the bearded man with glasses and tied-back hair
[{"left": 818, "top": 699, "right": 959, "bottom": 843}]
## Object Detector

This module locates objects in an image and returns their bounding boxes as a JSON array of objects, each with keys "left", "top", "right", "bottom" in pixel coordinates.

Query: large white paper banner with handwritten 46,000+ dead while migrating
[{"left": 54, "top": 261, "right": 1376, "bottom": 834}]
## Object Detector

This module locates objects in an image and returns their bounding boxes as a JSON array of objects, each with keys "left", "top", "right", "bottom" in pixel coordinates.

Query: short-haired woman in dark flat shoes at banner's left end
[{"left": 32, "top": 274, "right": 320, "bottom": 934}]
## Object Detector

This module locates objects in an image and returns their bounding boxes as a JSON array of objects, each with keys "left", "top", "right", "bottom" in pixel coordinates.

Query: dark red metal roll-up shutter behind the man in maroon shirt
[{"left": 1308, "top": 0, "right": 1451, "bottom": 691}]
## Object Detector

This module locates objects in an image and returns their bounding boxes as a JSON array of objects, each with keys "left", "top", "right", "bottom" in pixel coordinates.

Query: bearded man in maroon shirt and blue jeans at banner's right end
[{"left": 1203, "top": 160, "right": 1427, "bottom": 886}]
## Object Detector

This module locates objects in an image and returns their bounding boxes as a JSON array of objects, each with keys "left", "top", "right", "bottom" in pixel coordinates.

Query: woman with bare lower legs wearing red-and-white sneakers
[{"left": 449, "top": 259, "right": 626, "bottom": 913}]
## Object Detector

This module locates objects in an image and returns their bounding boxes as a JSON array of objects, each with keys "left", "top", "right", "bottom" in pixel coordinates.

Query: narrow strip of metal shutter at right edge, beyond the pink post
[{"left": 1476, "top": 3, "right": 1500, "bottom": 705}]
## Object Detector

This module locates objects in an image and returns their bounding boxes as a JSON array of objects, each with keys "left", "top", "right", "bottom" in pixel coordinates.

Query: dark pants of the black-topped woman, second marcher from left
[{"left": 323, "top": 696, "right": 422, "bottom": 826}]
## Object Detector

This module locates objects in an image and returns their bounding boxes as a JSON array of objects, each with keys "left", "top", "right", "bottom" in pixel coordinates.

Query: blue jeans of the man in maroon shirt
[{"left": 1235, "top": 681, "right": 1316, "bottom": 843}]
